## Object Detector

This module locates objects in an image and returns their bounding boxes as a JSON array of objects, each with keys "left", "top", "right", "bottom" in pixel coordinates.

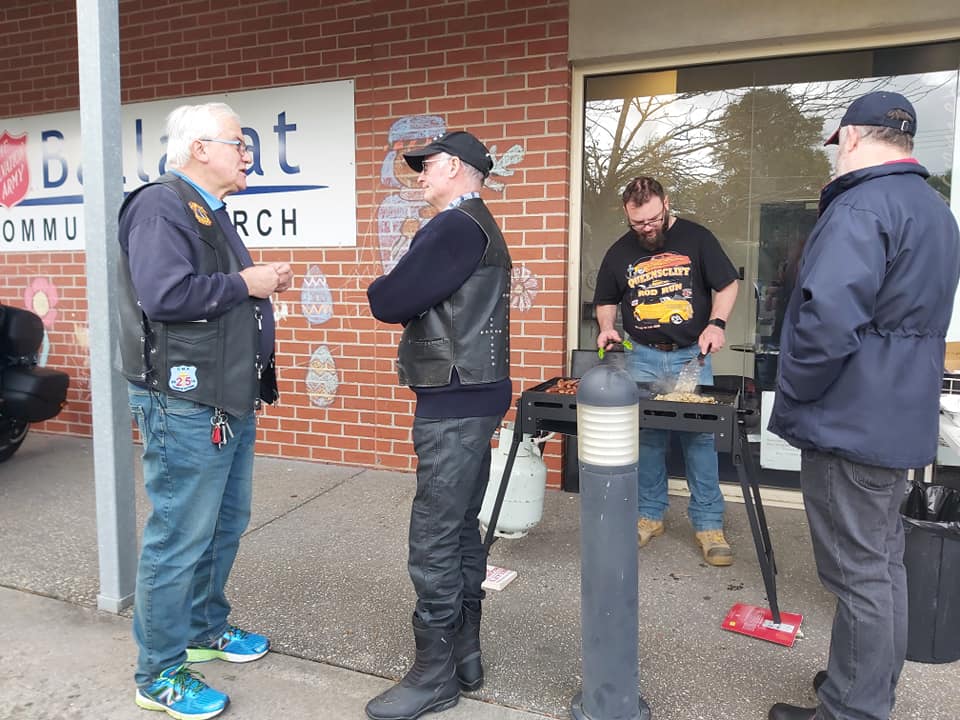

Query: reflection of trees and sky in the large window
[{"left": 581, "top": 71, "right": 957, "bottom": 342}]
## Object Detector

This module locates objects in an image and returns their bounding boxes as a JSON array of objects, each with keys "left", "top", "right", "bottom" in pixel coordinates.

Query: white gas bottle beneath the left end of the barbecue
[{"left": 479, "top": 423, "right": 550, "bottom": 539}]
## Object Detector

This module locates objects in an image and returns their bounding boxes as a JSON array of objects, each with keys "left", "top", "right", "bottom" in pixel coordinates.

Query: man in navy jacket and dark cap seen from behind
[{"left": 769, "top": 92, "right": 960, "bottom": 720}]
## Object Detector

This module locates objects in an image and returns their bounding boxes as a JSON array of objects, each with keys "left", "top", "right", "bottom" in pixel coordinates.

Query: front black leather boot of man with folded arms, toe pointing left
[{"left": 367, "top": 615, "right": 460, "bottom": 720}]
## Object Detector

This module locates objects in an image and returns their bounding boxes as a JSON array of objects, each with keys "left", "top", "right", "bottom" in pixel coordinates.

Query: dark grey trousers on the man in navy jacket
[{"left": 801, "top": 450, "right": 907, "bottom": 720}]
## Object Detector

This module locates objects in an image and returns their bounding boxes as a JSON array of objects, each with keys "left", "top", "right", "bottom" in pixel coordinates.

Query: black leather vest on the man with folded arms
[{"left": 397, "top": 198, "right": 512, "bottom": 387}]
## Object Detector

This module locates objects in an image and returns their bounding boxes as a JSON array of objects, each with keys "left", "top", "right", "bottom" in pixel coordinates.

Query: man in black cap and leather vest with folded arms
[{"left": 366, "top": 132, "right": 513, "bottom": 720}]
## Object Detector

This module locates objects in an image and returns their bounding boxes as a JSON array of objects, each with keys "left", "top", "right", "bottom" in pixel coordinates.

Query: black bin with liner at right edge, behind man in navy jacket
[{"left": 903, "top": 483, "right": 960, "bottom": 663}]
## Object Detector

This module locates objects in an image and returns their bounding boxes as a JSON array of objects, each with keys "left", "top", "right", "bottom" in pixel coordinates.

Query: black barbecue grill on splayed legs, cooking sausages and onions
[{"left": 484, "top": 377, "right": 780, "bottom": 624}]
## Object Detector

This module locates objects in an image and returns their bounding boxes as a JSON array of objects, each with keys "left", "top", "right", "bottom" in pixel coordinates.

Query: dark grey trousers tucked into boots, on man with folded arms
[{"left": 407, "top": 415, "right": 503, "bottom": 627}]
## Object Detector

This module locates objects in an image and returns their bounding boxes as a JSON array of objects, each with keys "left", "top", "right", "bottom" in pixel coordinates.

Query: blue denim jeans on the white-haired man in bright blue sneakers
[{"left": 129, "top": 385, "right": 257, "bottom": 687}]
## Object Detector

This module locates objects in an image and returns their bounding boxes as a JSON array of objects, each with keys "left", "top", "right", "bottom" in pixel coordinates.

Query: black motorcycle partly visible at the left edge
[{"left": 0, "top": 304, "right": 70, "bottom": 462}]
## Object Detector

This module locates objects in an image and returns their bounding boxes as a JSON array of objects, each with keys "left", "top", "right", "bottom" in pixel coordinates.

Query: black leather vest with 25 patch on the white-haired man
[{"left": 118, "top": 173, "right": 278, "bottom": 417}]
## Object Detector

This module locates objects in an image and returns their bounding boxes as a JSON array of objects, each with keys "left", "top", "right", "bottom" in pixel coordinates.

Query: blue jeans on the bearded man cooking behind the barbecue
[{"left": 625, "top": 343, "right": 724, "bottom": 532}]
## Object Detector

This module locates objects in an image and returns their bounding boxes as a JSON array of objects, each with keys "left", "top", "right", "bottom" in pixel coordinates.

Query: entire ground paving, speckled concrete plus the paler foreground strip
[{"left": 0, "top": 434, "right": 960, "bottom": 720}]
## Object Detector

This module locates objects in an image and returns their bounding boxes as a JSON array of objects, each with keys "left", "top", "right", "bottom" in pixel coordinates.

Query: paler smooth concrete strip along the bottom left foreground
[{"left": 0, "top": 588, "right": 543, "bottom": 720}]
